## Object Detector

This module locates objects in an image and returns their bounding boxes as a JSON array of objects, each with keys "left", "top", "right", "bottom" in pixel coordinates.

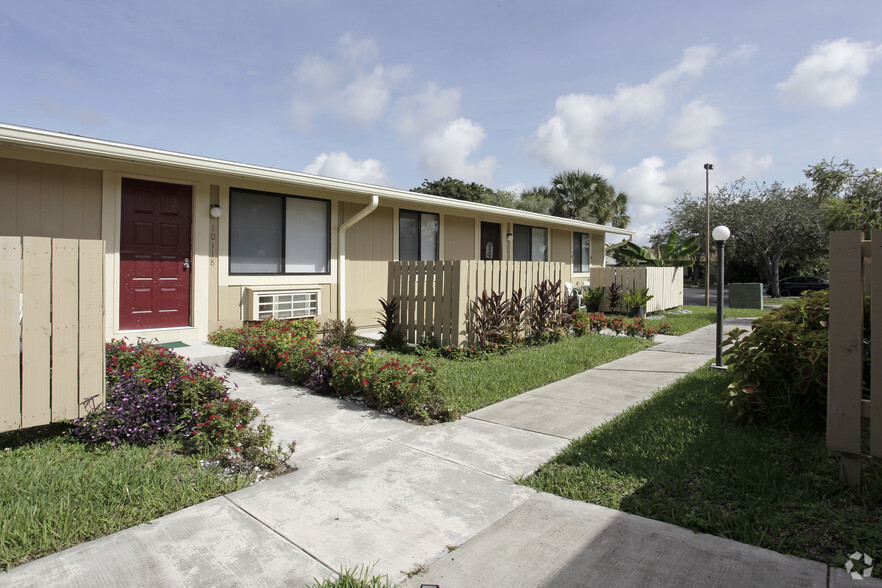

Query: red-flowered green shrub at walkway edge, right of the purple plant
[{"left": 189, "top": 398, "right": 296, "bottom": 471}]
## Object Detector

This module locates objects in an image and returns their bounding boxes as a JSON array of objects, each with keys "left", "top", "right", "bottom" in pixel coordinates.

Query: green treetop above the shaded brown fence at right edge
[{"left": 805, "top": 159, "right": 882, "bottom": 237}]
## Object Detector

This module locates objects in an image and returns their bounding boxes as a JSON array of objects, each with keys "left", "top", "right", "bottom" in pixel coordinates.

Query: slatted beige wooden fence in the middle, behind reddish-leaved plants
[{"left": 387, "top": 260, "right": 568, "bottom": 345}]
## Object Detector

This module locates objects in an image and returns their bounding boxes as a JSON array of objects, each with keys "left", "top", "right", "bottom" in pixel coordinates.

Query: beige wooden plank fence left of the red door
[{"left": 0, "top": 237, "right": 104, "bottom": 431}]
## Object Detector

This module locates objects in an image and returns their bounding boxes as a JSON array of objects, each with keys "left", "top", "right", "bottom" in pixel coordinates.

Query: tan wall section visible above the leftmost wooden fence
[{"left": 0, "top": 158, "right": 101, "bottom": 239}]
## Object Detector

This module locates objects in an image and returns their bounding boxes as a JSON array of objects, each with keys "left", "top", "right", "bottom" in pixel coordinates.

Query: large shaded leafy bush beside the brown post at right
[{"left": 723, "top": 291, "right": 830, "bottom": 429}]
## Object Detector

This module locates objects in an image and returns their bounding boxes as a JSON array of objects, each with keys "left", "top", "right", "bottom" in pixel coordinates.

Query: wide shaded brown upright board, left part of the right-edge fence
[{"left": 827, "top": 231, "right": 864, "bottom": 494}]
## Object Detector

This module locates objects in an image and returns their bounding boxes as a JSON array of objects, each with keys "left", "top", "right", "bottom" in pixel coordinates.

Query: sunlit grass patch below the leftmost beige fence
[{"left": 0, "top": 426, "right": 252, "bottom": 570}]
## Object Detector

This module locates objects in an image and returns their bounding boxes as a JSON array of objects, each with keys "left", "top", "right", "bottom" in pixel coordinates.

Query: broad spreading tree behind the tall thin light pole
[{"left": 665, "top": 179, "right": 827, "bottom": 296}]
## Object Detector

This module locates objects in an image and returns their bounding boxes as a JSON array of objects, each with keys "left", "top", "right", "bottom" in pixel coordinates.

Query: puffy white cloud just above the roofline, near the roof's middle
[{"left": 420, "top": 118, "right": 496, "bottom": 184}]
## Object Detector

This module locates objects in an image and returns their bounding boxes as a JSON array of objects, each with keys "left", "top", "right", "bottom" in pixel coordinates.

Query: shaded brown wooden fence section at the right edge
[{"left": 827, "top": 231, "right": 882, "bottom": 492}]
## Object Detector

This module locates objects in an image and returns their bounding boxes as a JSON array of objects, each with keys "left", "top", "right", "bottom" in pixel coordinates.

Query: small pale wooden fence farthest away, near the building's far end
[{"left": 590, "top": 266, "right": 683, "bottom": 312}]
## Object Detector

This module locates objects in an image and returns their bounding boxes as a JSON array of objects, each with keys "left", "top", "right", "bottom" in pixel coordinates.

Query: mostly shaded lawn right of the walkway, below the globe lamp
[{"left": 522, "top": 368, "right": 882, "bottom": 577}]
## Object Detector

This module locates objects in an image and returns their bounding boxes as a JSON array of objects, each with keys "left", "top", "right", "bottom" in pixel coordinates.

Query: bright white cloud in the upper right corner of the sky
[{"left": 776, "top": 38, "right": 882, "bottom": 108}]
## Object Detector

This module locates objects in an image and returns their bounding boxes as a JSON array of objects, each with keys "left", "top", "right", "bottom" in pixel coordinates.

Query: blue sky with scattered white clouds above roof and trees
[{"left": 0, "top": 0, "right": 882, "bottom": 240}]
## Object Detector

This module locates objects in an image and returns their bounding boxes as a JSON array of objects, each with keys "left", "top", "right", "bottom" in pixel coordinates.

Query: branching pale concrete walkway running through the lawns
[{"left": 0, "top": 321, "right": 882, "bottom": 588}]
